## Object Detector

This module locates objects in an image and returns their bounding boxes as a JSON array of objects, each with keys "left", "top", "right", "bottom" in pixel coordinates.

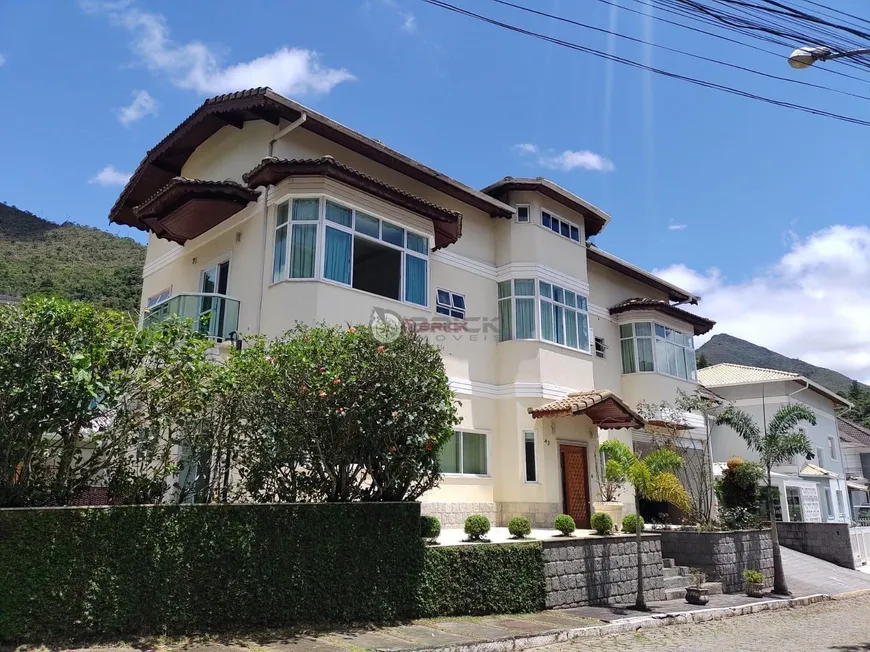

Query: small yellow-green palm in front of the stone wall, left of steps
[{"left": 598, "top": 439, "right": 689, "bottom": 611}]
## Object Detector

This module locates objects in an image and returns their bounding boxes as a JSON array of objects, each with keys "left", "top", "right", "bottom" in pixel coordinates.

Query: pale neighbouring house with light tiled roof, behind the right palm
[{"left": 698, "top": 364, "right": 851, "bottom": 522}]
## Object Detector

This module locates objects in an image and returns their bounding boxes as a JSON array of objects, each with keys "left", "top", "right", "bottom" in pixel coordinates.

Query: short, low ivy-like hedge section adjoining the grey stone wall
[{"left": 419, "top": 543, "right": 544, "bottom": 617}]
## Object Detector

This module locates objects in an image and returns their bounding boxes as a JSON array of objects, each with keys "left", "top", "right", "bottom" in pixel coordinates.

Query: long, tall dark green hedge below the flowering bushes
[{"left": 0, "top": 503, "right": 424, "bottom": 642}]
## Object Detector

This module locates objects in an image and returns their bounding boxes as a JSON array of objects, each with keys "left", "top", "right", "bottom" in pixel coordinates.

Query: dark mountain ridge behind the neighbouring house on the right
[{"left": 697, "top": 334, "right": 870, "bottom": 394}]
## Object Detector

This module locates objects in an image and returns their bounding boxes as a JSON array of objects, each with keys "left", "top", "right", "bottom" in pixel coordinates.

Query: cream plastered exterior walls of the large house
[{"left": 135, "top": 103, "right": 697, "bottom": 525}]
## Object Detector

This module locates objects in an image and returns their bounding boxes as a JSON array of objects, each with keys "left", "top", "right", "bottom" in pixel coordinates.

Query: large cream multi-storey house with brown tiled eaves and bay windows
[{"left": 116, "top": 89, "right": 713, "bottom": 527}]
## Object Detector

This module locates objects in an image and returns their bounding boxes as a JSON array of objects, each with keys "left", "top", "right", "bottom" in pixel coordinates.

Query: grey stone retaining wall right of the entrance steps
[{"left": 659, "top": 530, "right": 773, "bottom": 593}]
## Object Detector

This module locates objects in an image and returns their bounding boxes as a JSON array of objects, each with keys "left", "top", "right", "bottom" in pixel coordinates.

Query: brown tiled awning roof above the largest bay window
[{"left": 242, "top": 156, "right": 462, "bottom": 249}]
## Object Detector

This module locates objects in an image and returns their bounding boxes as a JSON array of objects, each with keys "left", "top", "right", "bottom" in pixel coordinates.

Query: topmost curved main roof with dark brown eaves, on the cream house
[{"left": 109, "top": 87, "right": 514, "bottom": 229}]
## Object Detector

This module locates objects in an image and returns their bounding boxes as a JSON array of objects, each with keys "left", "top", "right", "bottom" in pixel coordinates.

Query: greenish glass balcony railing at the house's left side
[{"left": 144, "top": 292, "right": 239, "bottom": 341}]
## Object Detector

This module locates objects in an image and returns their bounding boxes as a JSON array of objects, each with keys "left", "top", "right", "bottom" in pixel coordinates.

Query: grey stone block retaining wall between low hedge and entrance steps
[{"left": 543, "top": 534, "right": 664, "bottom": 609}]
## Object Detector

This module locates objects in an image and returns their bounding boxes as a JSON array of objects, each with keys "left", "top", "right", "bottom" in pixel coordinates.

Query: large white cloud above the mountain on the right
[{"left": 653, "top": 226, "right": 870, "bottom": 382}]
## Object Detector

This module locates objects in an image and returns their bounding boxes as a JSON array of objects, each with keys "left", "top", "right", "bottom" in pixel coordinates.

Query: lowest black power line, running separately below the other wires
[{"left": 422, "top": 0, "right": 870, "bottom": 127}]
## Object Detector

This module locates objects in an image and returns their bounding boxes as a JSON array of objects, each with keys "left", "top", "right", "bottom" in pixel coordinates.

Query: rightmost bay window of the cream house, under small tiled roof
[{"left": 619, "top": 321, "right": 697, "bottom": 380}]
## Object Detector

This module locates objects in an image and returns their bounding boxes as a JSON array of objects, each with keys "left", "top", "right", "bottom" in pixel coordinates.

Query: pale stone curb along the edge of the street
[{"left": 376, "top": 590, "right": 832, "bottom": 652}]
